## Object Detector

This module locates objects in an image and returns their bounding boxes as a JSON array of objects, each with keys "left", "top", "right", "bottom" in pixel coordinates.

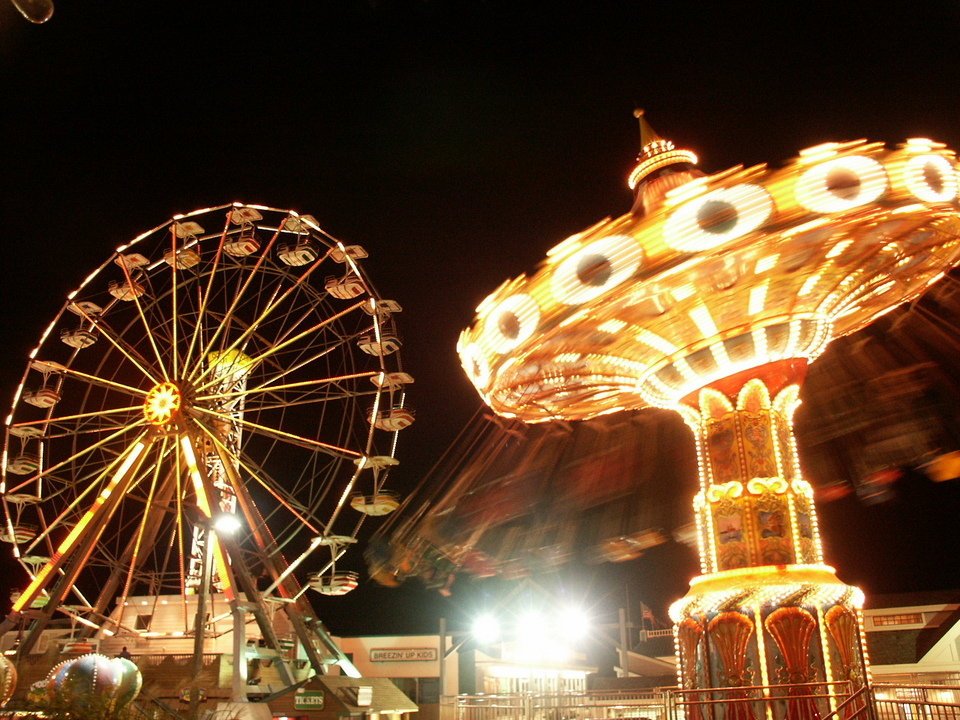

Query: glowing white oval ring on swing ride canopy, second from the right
[{"left": 794, "top": 155, "right": 887, "bottom": 214}]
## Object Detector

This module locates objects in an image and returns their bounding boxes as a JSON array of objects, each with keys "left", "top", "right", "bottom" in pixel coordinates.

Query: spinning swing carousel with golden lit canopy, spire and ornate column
[{"left": 372, "top": 113, "right": 960, "bottom": 718}]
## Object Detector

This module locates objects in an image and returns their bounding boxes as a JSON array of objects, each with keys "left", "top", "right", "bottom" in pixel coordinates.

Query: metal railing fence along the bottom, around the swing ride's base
[{"left": 450, "top": 683, "right": 960, "bottom": 720}]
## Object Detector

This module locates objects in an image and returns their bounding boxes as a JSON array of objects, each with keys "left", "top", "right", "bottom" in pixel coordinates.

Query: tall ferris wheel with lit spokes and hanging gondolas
[{"left": 0, "top": 204, "right": 414, "bottom": 662}]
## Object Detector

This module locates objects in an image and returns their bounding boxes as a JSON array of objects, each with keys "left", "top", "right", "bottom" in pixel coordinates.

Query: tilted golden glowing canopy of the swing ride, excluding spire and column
[{"left": 458, "top": 140, "right": 960, "bottom": 422}]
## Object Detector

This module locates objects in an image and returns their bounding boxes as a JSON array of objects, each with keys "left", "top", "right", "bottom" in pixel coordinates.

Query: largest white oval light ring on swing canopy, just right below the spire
[{"left": 663, "top": 183, "right": 773, "bottom": 252}]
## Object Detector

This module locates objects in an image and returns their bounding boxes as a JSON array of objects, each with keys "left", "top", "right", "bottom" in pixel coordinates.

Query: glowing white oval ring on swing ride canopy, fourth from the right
[{"left": 551, "top": 235, "right": 644, "bottom": 305}]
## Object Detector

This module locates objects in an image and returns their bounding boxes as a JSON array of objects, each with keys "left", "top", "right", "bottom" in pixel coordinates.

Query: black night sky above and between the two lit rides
[{"left": 0, "top": 0, "right": 960, "bottom": 632}]
